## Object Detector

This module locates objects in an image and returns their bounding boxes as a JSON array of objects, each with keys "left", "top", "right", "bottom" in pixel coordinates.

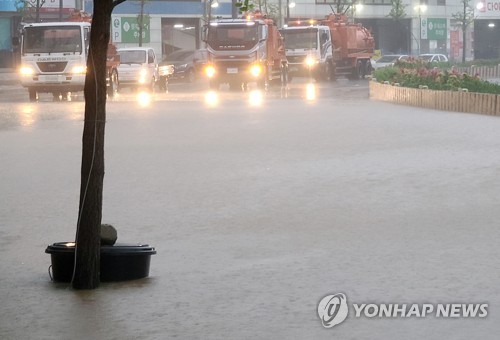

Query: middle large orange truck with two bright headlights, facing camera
[{"left": 204, "top": 11, "right": 288, "bottom": 89}]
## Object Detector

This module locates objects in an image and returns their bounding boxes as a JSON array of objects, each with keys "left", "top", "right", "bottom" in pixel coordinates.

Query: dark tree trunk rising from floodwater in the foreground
[{"left": 72, "top": 0, "right": 113, "bottom": 289}]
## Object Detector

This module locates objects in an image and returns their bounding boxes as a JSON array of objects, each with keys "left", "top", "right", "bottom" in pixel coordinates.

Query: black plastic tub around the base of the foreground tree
[{"left": 45, "top": 242, "right": 156, "bottom": 282}]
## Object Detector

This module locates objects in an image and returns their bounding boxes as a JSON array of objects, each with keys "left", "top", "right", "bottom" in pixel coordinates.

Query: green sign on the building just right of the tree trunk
[{"left": 111, "top": 16, "right": 150, "bottom": 43}]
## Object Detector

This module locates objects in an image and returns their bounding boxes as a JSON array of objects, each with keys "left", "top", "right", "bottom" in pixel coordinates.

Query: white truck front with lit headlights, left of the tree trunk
[{"left": 19, "top": 22, "right": 90, "bottom": 101}]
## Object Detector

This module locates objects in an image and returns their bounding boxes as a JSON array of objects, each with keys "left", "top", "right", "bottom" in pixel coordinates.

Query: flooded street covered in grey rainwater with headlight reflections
[{"left": 0, "top": 80, "right": 500, "bottom": 340}]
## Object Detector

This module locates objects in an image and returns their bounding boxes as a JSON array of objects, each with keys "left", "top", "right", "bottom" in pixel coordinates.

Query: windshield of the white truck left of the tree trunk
[{"left": 23, "top": 26, "right": 82, "bottom": 54}]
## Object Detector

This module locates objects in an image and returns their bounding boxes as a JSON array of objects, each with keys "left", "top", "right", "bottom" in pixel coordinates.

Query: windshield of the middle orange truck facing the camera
[{"left": 207, "top": 25, "right": 259, "bottom": 50}]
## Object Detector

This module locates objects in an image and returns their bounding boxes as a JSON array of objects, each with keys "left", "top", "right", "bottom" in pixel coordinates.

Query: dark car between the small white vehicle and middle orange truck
[{"left": 160, "top": 49, "right": 207, "bottom": 83}]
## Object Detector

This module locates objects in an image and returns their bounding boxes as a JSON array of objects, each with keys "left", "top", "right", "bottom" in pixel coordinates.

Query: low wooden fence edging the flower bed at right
[{"left": 370, "top": 80, "right": 500, "bottom": 116}]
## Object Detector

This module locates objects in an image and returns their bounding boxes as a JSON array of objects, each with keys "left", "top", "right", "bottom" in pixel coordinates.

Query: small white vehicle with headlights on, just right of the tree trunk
[{"left": 117, "top": 47, "right": 159, "bottom": 91}]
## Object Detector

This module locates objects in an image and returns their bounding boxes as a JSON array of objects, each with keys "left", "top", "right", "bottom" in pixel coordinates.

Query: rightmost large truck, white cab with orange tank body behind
[{"left": 281, "top": 13, "right": 375, "bottom": 80}]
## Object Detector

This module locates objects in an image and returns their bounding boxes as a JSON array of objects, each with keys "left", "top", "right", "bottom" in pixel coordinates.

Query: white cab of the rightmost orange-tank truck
[{"left": 280, "top": 22, "right": 334, "bottom": 81}]
